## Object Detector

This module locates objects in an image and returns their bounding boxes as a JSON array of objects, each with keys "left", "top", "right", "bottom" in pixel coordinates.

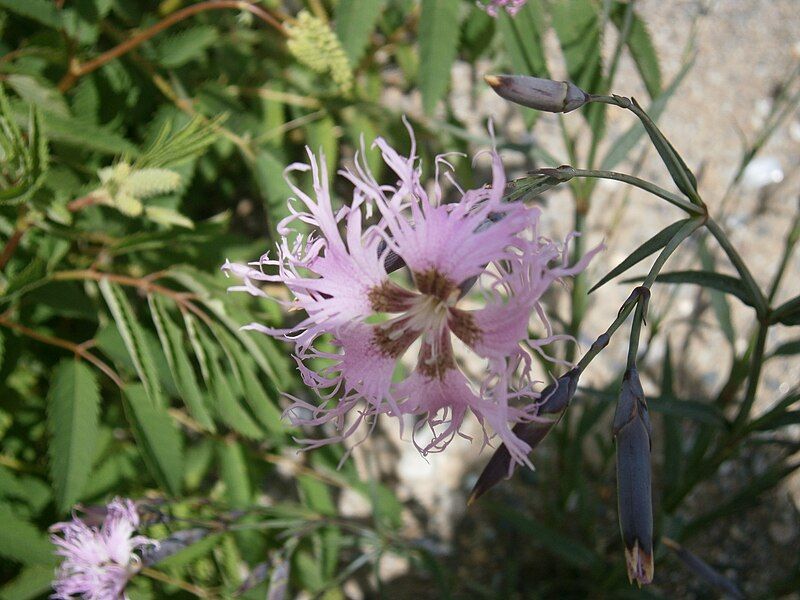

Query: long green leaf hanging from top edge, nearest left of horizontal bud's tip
[{"left": 419, "top": 0, "right": 460, "bottom": 115}]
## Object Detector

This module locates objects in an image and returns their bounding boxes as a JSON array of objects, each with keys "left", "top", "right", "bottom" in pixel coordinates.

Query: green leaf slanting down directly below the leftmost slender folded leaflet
[{"left": 125, "top": 384, "right": 183, "bottom": 496}]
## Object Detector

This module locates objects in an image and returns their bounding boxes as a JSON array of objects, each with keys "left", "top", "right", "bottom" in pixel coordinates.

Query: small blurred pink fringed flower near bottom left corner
[{"left": 50, "top": 498, "right": 158, "bottom": 600}]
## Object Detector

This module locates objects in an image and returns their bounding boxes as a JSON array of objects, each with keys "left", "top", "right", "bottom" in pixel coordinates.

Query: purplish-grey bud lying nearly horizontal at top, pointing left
[{"left": 484, "top": 75, "right": 590, "bottom": 113}]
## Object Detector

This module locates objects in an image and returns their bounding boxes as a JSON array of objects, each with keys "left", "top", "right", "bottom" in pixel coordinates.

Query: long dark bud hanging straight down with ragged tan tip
[{"left": 614, "top": 367, "right": 653, "bottom": 585}]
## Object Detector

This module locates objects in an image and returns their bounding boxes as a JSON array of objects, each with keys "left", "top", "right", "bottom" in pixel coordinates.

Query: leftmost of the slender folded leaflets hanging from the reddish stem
[{"left": 99, "top": 278, "right": 166, "bottom": 407}]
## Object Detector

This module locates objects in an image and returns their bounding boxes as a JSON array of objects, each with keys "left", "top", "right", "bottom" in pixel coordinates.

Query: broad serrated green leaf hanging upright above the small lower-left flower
[{"left": 47, "top": 359, "right": 100, "bottom": 512}]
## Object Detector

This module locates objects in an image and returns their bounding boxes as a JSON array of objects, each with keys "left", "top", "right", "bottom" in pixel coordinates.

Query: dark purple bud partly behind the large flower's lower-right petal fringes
[{"left": 467, "top": 368, "right": 581, "bottom": 504}]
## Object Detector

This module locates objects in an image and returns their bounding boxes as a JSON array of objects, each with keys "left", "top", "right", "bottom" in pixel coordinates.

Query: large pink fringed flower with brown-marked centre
[{"left": 223, "top": 122, "right": 591, "bottom": 464}]
